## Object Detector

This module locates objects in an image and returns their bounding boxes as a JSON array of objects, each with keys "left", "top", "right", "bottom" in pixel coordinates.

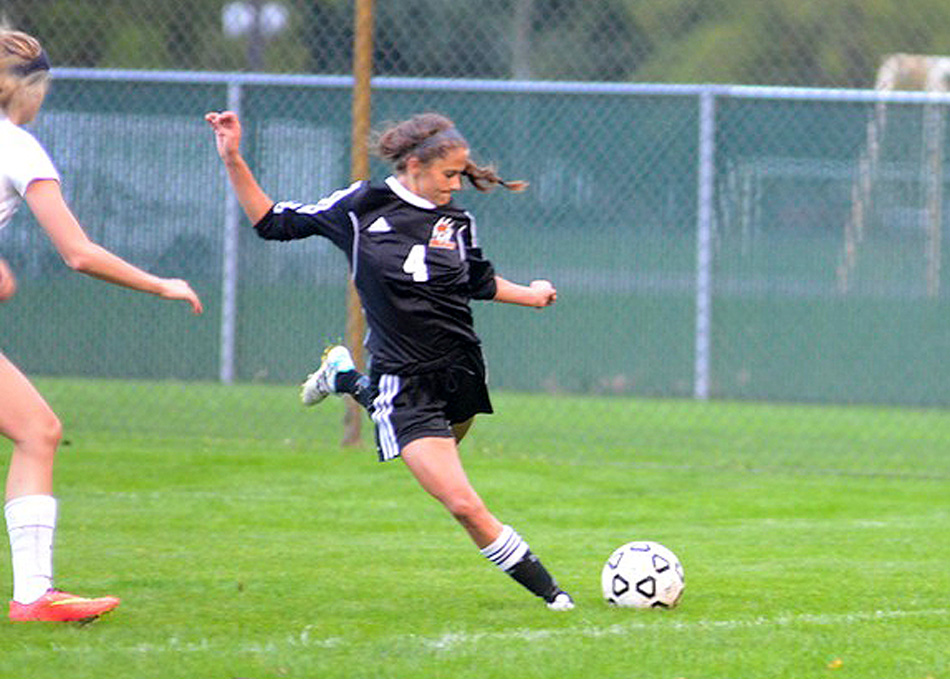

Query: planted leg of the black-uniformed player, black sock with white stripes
[{"left": 402, "top": 438, "right": 573, "bottom": 610}]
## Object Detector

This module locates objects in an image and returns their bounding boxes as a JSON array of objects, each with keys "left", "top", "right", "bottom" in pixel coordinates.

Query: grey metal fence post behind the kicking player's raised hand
[{"left": 220, "top": 81, "right": 242, "bottom": 384}]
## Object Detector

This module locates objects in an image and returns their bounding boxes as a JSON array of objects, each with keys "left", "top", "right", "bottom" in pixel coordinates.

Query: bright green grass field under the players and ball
[{"left": 0, "top": 380, "right": 950, "bottom": 679}]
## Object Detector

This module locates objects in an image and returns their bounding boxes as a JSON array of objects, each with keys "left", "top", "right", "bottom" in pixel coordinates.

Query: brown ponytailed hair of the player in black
[{"left": 373, "top": 113, "right": 528, "bottom": 191}]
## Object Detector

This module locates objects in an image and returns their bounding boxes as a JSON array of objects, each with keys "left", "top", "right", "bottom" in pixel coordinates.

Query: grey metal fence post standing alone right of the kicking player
[{"left": 693, "top": 88, "right": 716, "bottom": 400}]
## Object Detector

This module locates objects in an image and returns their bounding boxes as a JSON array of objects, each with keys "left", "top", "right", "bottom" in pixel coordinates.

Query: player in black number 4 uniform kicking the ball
[{"left": 205, "top": 112, "right": 574, "bottom": 610}]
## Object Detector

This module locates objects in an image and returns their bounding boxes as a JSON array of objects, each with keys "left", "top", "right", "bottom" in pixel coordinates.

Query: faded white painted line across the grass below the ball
[{"left": 47, "top": 608, "right": 950, "bottom": 655}]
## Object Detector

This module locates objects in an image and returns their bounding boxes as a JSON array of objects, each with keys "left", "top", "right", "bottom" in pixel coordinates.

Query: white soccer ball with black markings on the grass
[{"left": 600, "top": 542, "right": 686, "bottom": 608}]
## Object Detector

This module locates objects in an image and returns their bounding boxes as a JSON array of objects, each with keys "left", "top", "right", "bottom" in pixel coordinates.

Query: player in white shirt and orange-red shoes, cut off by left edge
[{"left": 0, "top": 28, "right": 201, "bottom": 622}]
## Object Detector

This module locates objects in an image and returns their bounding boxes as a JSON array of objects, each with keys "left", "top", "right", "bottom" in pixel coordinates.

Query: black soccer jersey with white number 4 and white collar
[{"left": 254, "top": 177, "right": 496, "bottom": 375}]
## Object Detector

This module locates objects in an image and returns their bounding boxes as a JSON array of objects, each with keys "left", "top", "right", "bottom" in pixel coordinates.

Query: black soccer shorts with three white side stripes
[{"left": 370, "top": 348, "right": 493, "bottom": 462}]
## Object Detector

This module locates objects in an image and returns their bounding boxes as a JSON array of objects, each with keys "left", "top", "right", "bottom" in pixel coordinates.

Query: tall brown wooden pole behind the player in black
[{"left": 343, "top": 0, "right": 373, "bottom": 446}]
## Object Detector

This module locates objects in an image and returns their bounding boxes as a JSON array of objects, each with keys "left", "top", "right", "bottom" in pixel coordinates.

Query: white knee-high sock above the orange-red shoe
[{"left": 4, "top": 495, "right": 56, "bottom": 604}]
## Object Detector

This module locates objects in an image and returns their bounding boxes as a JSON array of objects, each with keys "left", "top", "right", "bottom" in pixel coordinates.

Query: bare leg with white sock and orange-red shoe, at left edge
[{"left": 0, "top": 354, "right": 119, "bottom": 621}]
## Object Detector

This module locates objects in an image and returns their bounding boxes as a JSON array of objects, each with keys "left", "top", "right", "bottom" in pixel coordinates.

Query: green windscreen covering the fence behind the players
[{"left": 0, "top": 75, "right": 950, "bottom": 406}]
